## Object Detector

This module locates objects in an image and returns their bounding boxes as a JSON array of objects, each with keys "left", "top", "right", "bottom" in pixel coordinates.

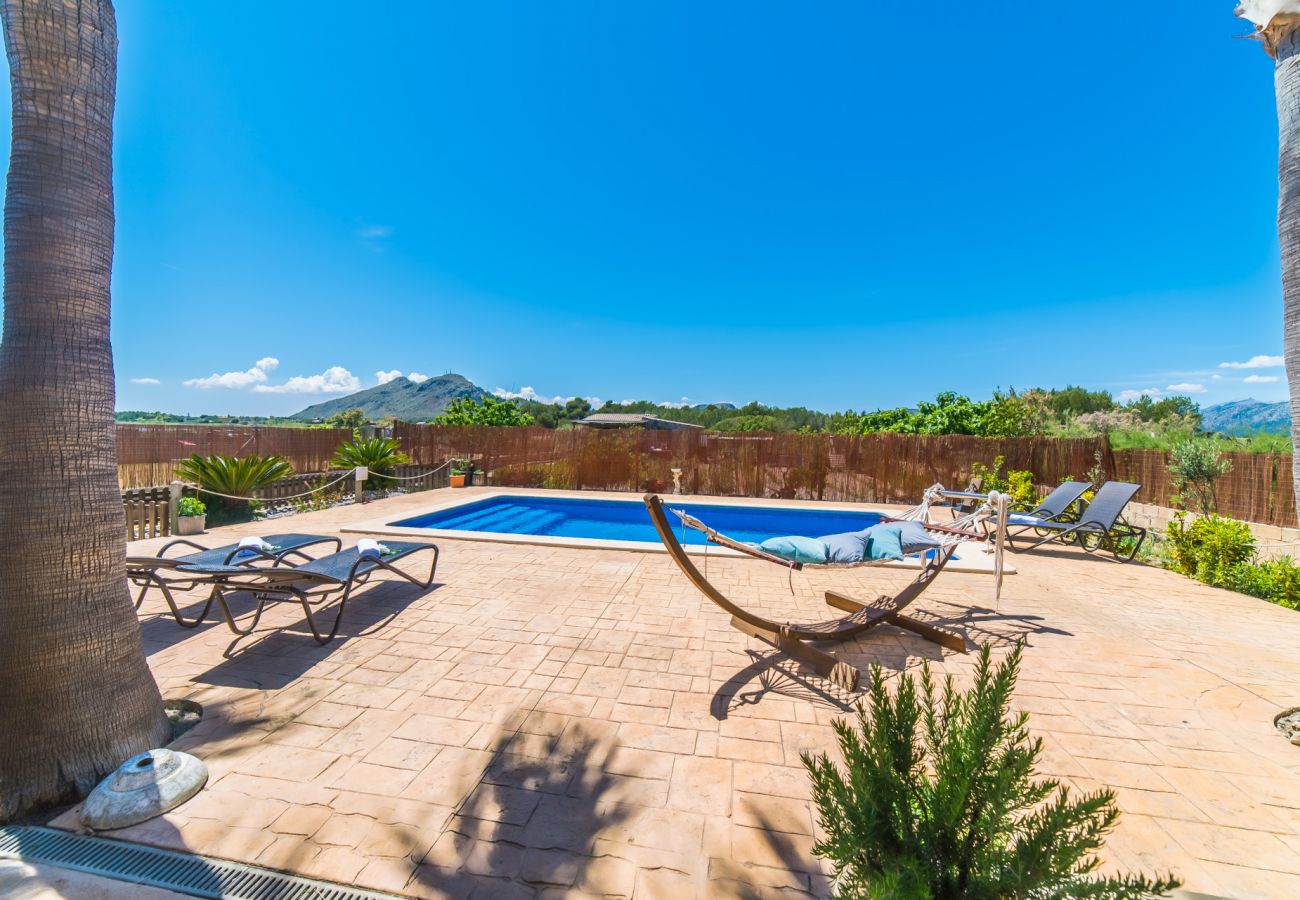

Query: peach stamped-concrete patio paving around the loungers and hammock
[{"left": 55, "top": 492, "right": 1300, "bottom": 897}]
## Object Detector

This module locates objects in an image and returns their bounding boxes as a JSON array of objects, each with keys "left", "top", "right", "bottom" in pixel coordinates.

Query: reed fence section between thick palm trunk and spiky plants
[{"left": 117, "top": 424, "right": 352, "bottom": 488}]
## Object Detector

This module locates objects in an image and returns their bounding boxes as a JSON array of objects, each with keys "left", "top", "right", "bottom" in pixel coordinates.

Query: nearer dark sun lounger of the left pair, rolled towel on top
[{"left": 179, "top": 541, "right": 438, "bottom": 644}]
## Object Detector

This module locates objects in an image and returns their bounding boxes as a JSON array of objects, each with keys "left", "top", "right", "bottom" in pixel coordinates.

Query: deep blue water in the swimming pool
[{"left": 391, "top": 496, "right": 880, "bottom": 544}]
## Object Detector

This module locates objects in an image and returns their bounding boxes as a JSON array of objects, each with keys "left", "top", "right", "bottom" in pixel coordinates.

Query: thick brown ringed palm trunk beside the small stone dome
[{"left": 0, "top": 0, "right": 168, "bottom": 822}]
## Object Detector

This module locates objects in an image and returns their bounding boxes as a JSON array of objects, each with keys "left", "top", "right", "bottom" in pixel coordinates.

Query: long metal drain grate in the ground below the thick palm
[{"left": 0, "top": 826, "right": 405, "bottom": 900}]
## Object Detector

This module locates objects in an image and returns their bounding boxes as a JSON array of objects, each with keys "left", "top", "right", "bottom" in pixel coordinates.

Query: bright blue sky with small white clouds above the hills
[{"left": 4, "top": 0, "right": 1286, "bottom": 414}]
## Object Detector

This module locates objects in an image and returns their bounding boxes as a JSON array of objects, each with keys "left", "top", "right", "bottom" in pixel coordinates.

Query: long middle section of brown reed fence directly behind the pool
[{"left": 394, "top": 423, "right": 1110, "bottom": 503}]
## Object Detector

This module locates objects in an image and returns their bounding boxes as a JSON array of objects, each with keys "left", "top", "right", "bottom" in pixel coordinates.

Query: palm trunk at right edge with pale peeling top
[{"left": 1236, "top": 0, "right": 1300, "bottom": 512}]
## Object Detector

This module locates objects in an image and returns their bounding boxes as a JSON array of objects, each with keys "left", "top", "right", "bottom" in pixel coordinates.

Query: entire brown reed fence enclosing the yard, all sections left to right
[{"left": 117, "top": 423, "right": 1297, "bottom": 540}]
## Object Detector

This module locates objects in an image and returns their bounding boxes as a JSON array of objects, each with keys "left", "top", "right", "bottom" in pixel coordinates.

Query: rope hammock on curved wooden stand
[{"left": 645, "top": 485, "right": 1008, "bottom": 691}]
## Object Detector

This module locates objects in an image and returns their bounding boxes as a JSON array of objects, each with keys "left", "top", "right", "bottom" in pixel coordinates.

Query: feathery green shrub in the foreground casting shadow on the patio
[{"left": 803, "top": 646, "right": 1179, "bottom": 900}]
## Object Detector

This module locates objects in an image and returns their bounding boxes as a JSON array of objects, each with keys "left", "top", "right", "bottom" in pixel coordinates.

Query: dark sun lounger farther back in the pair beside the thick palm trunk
[{"left": 126, "top": 535, "right": 343, "bottom": 628}]
